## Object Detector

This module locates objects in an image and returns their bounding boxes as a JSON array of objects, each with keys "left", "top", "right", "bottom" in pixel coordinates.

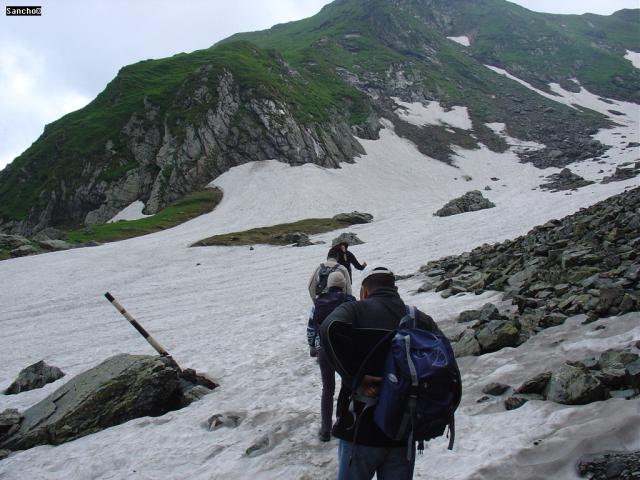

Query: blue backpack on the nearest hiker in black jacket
[{"left": 354, "top": 307, "right": 462, "bottom": 459}]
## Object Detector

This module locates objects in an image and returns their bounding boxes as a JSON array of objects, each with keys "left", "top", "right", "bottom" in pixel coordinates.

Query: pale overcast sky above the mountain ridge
[{"left": 0, "top": 0, "right": 640, "bottom": 169}]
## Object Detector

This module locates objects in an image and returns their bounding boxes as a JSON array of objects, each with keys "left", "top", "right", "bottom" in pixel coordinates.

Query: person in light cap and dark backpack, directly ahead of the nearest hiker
[{"left": 307, "top": 271, "right": 356, "bottom": 442}]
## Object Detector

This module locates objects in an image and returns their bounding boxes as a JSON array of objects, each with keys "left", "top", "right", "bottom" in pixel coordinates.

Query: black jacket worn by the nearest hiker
[{"left": 320, "top": 288, "right": 442, "bottom": 447}]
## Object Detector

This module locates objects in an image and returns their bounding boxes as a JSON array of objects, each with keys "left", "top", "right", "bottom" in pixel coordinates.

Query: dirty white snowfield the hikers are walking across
[{"left": 0, "top": 78, "right": 640, "bottom": 480}]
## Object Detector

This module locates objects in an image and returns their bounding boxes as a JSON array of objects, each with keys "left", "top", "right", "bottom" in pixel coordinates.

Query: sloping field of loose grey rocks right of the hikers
[{"left": 419, "top": 188, "right": 640, "bottom": 344}]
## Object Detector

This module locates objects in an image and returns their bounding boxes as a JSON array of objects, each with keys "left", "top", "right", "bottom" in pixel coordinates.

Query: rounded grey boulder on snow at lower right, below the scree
[{"left": 545, "top": 364, "right": 609, "bottom": 405}]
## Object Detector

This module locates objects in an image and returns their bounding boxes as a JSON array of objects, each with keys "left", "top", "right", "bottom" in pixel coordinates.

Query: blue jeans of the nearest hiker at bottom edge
[{"left": 338, "top": 440, "right": 416, "bottom": 480}]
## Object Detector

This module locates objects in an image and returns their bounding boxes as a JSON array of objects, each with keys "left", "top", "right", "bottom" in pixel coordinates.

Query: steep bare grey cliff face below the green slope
[{"left": 0, "top": 65, "right": 364, "bottom": 236}]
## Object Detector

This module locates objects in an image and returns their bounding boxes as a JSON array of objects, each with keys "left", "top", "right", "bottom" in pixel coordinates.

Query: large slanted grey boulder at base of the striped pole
[{"left": 0, "top": 354, "right": 179, "bottom": 450}]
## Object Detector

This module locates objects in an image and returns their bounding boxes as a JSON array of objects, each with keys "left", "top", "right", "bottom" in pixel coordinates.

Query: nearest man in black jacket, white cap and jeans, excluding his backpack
[{"left": 320, "top": 267, "right": 442, "bottom": 480}]
